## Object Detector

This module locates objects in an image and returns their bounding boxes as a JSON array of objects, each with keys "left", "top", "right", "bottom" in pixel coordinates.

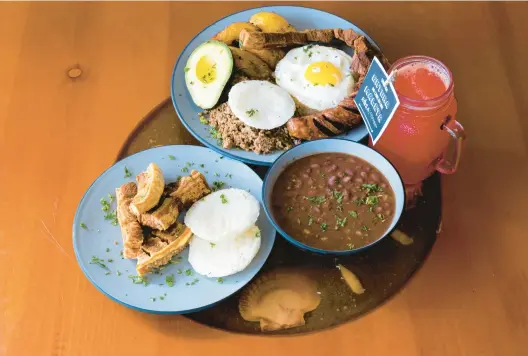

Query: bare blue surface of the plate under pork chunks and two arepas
[{"left": 73, "top": 146, "right": 276, "bottom": 314}]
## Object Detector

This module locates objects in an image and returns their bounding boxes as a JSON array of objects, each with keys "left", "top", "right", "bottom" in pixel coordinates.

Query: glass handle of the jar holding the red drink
[{"left": 435, "top": 115, "right": 466, "bottom": 174}]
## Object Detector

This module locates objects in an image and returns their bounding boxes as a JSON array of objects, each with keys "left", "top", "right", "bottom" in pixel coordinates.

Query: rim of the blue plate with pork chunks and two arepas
[{"left": 72, "top": 145, "right": 277, "bottom": 315}]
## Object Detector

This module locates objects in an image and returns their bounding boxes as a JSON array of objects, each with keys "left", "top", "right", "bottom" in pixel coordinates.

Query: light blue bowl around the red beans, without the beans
[{"left": 262, "top": 138, "right": 405, "bottom": 255}]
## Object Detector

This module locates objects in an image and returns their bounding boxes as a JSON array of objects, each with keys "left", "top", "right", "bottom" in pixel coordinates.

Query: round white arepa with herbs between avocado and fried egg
[{"left": 227, "top": 80, "right": 295, "bottom": 130}]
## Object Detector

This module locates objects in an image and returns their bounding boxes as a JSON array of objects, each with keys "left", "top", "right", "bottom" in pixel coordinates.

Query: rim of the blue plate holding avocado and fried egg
[{"left": 170, "top": 5, "right": 383, "bottom": 167}]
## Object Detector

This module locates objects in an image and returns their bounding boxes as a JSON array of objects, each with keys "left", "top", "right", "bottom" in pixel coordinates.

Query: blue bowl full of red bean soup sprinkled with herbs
[{"left": 262, "top": 139, "right": 405, "bottom": 255}]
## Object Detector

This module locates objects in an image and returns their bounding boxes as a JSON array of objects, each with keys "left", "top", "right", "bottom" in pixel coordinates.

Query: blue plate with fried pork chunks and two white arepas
[{"left": 73, "top": 145, "right": 275, "bottom": 314}]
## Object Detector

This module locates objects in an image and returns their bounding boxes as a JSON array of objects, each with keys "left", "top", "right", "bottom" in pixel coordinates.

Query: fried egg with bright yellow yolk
[{"left": 275, "top": 45, "right": 354, "bottom": 110}]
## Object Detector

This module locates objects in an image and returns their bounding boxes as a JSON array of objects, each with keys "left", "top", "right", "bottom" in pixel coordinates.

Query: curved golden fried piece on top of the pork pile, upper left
[{"left": 130, "top": 163, "right": 165, "bottom": 216}]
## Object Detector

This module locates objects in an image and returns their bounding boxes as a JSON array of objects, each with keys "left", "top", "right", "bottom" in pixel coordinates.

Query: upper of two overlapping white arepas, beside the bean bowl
[{"left": 185, "top": 188, "right": 260, "bottom": 242}]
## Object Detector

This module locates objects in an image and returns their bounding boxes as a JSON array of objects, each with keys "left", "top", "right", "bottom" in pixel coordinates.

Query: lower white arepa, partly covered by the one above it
[{"left": 189, "top": 226, "right": 261, "bottom": 277}]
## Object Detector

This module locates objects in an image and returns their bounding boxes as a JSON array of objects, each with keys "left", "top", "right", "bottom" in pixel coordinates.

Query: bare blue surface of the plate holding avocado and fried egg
[{"left": 171, "top": 6, "right": 379, "bottom": 166}]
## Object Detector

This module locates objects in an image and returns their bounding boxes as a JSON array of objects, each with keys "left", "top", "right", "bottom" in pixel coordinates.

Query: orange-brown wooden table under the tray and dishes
[{"left": 0, "top": 2, "right": 528, "bottom": 356}]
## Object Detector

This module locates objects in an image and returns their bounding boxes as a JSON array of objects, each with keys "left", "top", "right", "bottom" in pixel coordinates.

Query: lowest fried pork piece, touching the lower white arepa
[{"left": 136, "top": 227, "right": 192, "bottom": 276}]
